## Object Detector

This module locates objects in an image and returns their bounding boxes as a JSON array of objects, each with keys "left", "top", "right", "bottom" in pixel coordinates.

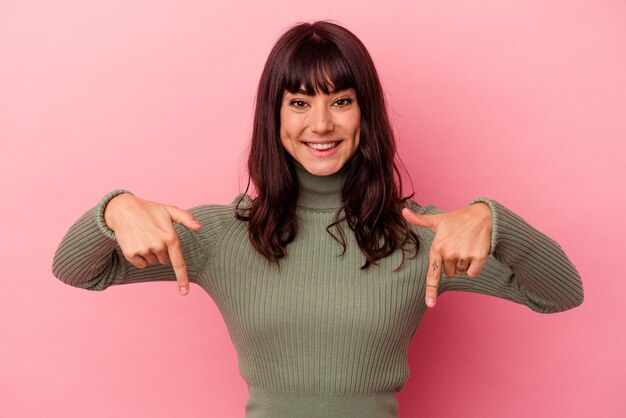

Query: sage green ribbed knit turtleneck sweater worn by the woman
[{"left": 53, "top": 168, "right": 583, "bottom": 418}]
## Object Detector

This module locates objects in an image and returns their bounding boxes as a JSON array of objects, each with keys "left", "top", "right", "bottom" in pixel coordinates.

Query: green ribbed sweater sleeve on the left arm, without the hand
[{"left": 52, "top": 189, "right": 222, "bottom": 290}]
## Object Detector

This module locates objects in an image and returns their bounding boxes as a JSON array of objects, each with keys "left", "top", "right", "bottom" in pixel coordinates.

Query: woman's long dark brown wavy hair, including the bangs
[{"left": 237, "top": 21, "right": 418, "bottom": 268}]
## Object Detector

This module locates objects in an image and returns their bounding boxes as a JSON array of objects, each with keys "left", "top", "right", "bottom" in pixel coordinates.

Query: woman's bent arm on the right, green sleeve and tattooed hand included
[{"left": 403, "top": 198, "right": 584, "bottom": 313}]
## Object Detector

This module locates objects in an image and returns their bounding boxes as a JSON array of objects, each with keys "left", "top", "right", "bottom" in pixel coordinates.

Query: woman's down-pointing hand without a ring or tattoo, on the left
[{"left": 104, "top": 193, "right": 202, "bottom": 295}]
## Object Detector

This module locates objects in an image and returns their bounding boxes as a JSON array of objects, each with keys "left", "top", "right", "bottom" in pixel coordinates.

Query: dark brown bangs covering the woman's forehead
[{"left": 284, "top": 37, "right": 356, "bottom": 96}]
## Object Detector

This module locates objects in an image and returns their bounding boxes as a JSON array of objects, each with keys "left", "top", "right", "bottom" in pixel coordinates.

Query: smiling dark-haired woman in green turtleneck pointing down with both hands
[{"left": 53, "top": 22, "right": 583, "bottom": 418}]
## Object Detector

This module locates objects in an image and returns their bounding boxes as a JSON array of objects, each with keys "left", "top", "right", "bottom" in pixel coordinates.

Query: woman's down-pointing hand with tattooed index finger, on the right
[{"left": 402, "top": 203, "right": 492, "bottom": 308}]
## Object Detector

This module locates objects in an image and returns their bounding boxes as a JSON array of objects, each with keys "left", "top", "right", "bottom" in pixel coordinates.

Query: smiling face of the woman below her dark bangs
[{"left": 280, "top": 88, "right": 361, "bottom": 176}]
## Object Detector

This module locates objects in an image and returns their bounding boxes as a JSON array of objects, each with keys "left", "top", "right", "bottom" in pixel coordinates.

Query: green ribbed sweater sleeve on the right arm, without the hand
[{"left": 417, "top": 198, "right": 584, "bottom": 313}]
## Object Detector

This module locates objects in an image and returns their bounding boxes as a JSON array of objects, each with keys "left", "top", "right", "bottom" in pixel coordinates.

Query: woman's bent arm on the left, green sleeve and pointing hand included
[{"left": 52, "top": 190, "right": 219, "bottom": 295}]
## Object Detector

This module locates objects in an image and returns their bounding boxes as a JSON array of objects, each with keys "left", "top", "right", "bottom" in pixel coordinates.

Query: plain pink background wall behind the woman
[{"left": 0, "top": 0, "right": 626, "bottom": 418}]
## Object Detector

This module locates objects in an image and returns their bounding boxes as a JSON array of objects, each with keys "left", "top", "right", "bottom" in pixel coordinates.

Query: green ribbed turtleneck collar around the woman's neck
[{"left": 294, "top": 161, "right": 346, "bottom": 210}]
